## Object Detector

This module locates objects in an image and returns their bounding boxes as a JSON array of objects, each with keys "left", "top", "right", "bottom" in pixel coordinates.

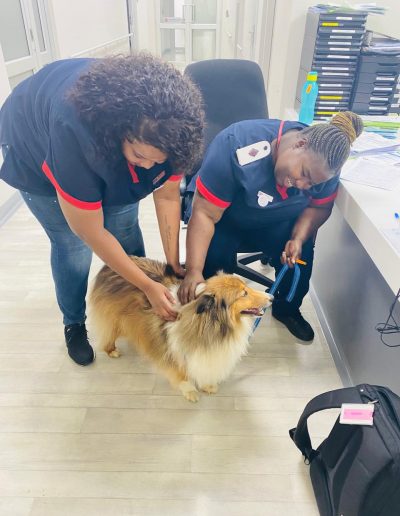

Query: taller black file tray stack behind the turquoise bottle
[{"left": 295, "top": 6, "right": 368, "bottom": 120}]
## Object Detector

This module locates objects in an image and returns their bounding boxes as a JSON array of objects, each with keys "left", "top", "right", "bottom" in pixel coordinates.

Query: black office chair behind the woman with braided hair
[{"left": 182, "top": 59, "right": 273, "bottom": 287}]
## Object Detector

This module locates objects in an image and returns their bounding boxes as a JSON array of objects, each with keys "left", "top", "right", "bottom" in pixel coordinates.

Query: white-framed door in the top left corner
[{"left": 0, "top": 0, "right": 52, "bottom": 88}]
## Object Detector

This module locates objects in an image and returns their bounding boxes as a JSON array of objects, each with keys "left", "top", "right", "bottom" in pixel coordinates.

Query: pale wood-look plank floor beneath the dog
[{"left": 0, "top": 195, "right": 340, "bottom": 516}]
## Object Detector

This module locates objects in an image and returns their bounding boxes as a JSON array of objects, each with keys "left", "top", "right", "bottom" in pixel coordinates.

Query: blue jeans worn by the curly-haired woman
[{"left": 21, "top": 192, "right": 145, "bottom": 325}]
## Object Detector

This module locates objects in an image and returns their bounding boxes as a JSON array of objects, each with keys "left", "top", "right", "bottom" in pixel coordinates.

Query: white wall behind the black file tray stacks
[{"left": 267, "top": 0, "right": 400, "bottom": 118}]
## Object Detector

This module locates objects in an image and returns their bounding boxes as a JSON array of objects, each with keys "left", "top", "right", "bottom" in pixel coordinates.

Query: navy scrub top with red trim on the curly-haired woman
[{"left": 0, "top": 59, "right": 181, "bottom": 210}]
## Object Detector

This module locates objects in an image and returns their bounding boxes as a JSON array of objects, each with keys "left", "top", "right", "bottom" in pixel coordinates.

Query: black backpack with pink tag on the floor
[{"left": 289, "top": 384, "right": 400, "bottom": 516}]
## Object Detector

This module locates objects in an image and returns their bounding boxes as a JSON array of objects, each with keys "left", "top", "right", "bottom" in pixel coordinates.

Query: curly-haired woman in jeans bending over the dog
[{"left": 0, "top": 54, "right": 203, "bottom": 365}]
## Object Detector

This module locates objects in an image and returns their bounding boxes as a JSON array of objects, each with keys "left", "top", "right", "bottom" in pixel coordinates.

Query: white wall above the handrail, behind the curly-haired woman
[{"left": 48, "top": 0, "right": 128, "bottom": 58}]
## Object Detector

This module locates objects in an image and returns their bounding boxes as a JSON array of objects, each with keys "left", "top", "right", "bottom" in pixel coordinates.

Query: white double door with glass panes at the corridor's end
[{"left": 158, "top": 0, "right": 220, "bottom": 70}]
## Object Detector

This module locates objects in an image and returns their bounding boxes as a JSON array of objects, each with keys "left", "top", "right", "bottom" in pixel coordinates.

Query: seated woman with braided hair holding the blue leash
[{"left": 179, "top": 111, "right": 362, "bottom": 341}]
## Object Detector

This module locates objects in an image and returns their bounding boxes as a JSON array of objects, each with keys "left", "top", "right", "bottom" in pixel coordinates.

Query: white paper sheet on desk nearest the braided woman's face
[{"left": 340, "top": 155, "right": 400, "bottom": 191}]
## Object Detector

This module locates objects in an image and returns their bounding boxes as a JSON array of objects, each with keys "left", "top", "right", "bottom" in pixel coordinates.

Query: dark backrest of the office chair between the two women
[{"left": 185, "top": 59, "right": 268, "bottom": 148}]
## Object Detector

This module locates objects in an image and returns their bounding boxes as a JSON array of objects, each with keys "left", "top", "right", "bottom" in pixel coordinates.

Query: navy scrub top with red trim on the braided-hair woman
[{"left": 196, "top": 120, "right": 339, "bottom": 228}]
